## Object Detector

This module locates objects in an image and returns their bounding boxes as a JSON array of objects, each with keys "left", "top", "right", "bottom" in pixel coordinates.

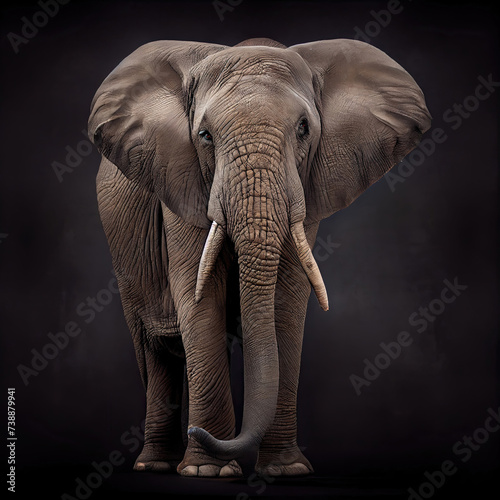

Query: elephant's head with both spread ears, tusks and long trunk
[{"left": 89, "top": 40, "right": 430, "bottom": 457}]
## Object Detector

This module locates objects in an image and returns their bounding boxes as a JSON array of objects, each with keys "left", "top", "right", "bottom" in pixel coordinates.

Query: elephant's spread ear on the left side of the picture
[{"left": 88, "top": 41, "right": 226, "bottom": 228}]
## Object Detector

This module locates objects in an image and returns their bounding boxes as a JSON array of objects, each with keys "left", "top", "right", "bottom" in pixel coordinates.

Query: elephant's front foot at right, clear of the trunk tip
[{"left": 255, "top": 446, "right": 314, "bottom": 477}]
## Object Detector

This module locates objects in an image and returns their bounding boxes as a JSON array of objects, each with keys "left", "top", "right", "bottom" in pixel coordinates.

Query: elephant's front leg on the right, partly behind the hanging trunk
[{"left": 255, "top": 226, "right": 317, "bottom": 476}]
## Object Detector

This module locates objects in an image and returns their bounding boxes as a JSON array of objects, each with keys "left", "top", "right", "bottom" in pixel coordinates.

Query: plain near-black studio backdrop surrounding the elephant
[{"left": 0, "top": 0, "right": 500, "bottom": 498}]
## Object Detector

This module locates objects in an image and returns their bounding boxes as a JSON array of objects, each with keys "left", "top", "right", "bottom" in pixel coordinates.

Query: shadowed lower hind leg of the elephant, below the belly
[{"left": 134, "top": 339, "right": 185, "bottom": 472}]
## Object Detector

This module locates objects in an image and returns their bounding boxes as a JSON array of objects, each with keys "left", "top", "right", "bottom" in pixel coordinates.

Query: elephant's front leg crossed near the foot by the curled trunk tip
[{"left": 164, "top": 209, "right": 241, "bottom": 477}]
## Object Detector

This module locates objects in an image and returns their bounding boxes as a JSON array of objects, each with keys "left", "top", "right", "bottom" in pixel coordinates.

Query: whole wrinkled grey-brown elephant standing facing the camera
[{"left": 89, "top": 39, "right": 430, "bottom": 476}]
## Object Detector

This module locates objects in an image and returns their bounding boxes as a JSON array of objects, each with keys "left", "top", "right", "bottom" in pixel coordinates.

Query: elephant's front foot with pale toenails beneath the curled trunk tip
[{"left": 177, "top": 436, "right": 243, "bottom": 477}]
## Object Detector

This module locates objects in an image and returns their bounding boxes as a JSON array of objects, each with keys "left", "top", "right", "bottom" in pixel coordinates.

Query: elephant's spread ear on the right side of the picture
[{"left": 290, "top": 39, "right": 431, "bottom": 221}]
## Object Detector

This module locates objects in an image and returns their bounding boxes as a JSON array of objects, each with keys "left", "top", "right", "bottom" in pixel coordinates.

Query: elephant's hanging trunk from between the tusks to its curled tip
[{"left": 189, "top": 233, "right": 280, "bottom": 460}]
